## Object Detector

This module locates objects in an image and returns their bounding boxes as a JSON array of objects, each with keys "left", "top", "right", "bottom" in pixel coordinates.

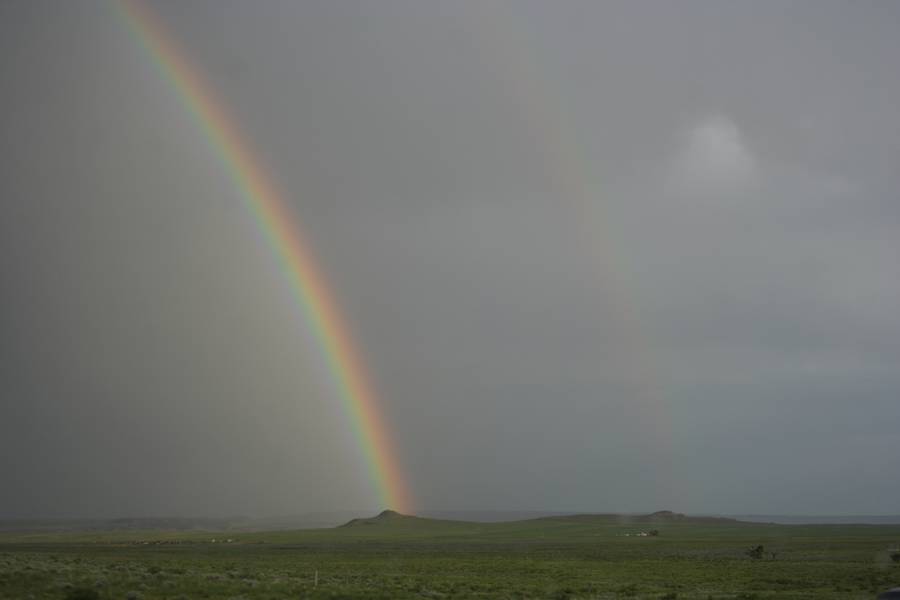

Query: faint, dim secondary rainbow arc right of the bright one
[{"left": 466, "top": 2, "right": 684, "bottom": 499}]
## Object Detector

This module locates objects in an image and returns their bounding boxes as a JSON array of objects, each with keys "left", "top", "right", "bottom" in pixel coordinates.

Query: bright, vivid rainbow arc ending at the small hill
[{"left": 118, "top": 0, "right": 413, "bottom": 512}]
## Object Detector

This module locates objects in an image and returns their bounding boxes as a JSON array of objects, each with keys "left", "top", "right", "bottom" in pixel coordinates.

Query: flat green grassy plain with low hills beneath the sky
[{"left": 0, "top": 514, "right": 900, "bottom": 600}]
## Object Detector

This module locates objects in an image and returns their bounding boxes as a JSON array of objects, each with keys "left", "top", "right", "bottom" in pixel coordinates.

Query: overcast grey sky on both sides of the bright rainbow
[{"left": 0, "top": 0, "right": 900, "bottom": 516}]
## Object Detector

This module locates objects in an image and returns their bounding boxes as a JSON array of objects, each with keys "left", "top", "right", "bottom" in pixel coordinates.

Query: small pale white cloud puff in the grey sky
[{"left": 669, "top": 115, "right": 759, "bottom": 197}]
